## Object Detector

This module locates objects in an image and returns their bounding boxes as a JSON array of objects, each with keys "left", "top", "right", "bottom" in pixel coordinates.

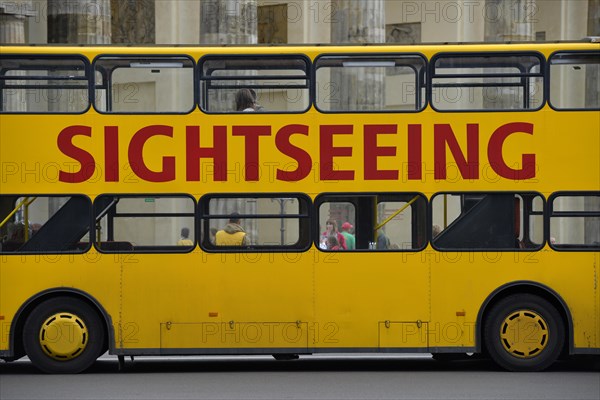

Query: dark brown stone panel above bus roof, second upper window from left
[{"left": 110, "top": 0, "right": 156, "bottom": 44}]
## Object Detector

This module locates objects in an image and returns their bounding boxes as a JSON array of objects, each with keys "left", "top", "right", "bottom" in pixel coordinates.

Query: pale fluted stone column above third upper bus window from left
[{"left": 200, "top": 0, "right": 258, "bottom": 44}]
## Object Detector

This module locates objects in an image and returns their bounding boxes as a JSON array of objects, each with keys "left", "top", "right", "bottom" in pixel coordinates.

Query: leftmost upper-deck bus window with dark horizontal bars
[{"left": 0, "top": 55, "right": 89, "bottom": 114}]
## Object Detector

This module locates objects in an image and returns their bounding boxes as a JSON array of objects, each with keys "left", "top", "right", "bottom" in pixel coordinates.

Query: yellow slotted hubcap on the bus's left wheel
[{"left": 40, "top": 313, "right": 89, "bottom": 361}]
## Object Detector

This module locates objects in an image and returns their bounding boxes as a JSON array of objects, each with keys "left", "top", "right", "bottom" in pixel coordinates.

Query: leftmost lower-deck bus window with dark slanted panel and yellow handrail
[{"left": 0, "top": 195, "right": 92, "bottom": 254}]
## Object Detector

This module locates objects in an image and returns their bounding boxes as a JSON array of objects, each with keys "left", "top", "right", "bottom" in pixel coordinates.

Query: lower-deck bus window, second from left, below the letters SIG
[{"left": 94, "top": 194, "right": 196, "bottom": 252}]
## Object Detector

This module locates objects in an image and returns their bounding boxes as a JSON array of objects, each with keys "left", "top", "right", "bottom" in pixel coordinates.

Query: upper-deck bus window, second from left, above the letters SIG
[{"left": 94, "top": 56, "right": 195, "bottom": 114}]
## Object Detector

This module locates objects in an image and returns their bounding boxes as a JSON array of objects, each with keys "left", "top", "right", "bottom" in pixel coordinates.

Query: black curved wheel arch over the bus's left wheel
[{"left": 4, "top": 287, "right": 115, "bottom": 360}]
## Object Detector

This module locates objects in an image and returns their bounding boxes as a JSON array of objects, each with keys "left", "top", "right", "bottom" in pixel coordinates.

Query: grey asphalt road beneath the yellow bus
[{"left": 0, "top": 355, "right": 600, "bottom": 400}]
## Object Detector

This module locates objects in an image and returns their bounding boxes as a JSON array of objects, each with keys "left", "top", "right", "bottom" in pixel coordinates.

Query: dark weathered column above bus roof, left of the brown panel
[{"left": 48, "top": 0, "right": 111, "bottom": 44}]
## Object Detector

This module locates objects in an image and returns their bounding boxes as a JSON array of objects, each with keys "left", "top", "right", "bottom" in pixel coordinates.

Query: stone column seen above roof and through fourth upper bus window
[{"left": 330, "top": 0, "right": 385, "bottom": 111}]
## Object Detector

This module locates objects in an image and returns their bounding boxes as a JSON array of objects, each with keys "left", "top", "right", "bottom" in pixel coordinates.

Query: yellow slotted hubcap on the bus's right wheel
[{"left": 500, "top": 310, "right": 550, "bottom": 358}]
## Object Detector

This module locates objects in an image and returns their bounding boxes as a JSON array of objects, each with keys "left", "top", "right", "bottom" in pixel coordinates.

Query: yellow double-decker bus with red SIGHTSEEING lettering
[{"left": 0, "top": 39, "right": 600, "bottom": 373}]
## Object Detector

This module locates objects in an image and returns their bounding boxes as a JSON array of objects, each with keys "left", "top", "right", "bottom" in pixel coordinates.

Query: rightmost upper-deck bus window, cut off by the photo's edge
[{"left": 549, "top": 52, "right": 600, "bottom": 110}]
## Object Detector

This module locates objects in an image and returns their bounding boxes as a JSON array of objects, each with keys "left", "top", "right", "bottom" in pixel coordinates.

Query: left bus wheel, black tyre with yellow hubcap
[{"left": 23, "top": 297, "right": 104, "bottom": 374}]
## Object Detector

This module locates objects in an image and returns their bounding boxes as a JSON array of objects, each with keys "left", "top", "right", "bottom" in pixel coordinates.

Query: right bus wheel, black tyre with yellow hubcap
[{"left": 484, "top": 294, "right": 565, "bottom": 371}]
